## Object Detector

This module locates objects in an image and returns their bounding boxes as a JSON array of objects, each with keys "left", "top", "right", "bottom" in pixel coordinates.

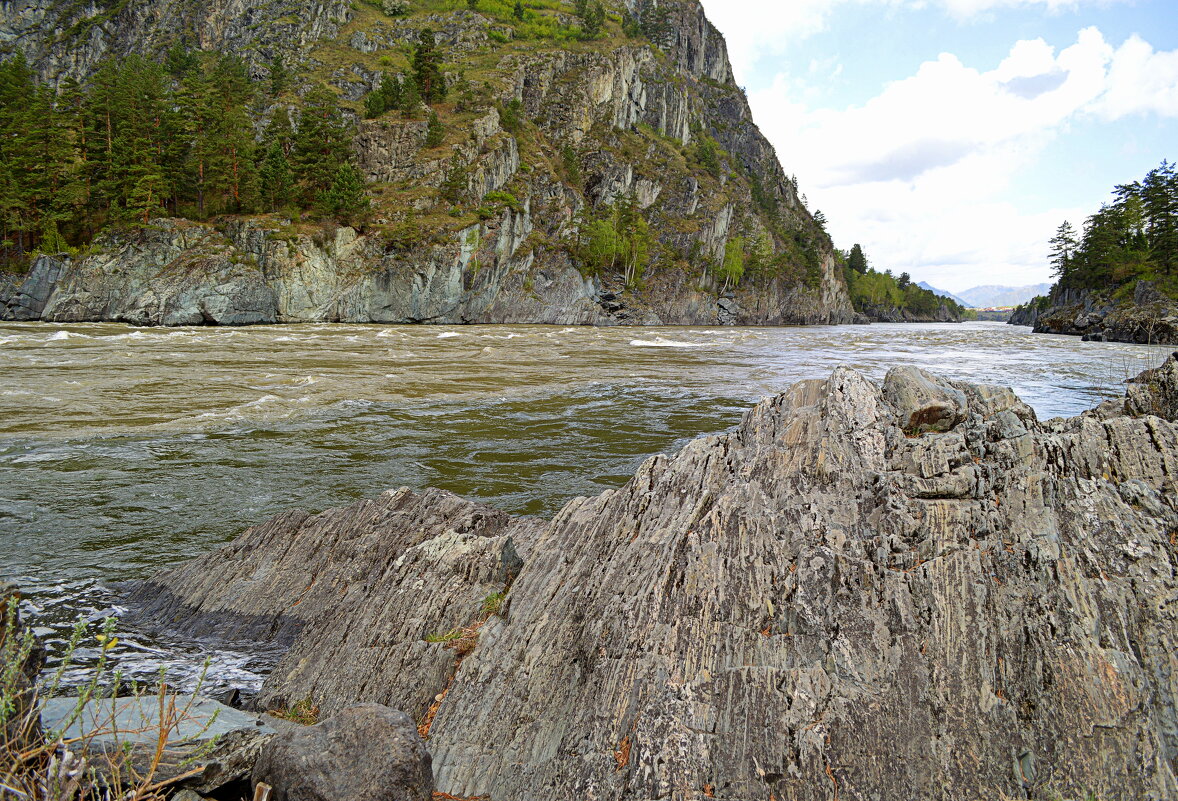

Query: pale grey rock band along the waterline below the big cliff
[{"left": 0, "top": 211, "right": 861, "bottom": 326}]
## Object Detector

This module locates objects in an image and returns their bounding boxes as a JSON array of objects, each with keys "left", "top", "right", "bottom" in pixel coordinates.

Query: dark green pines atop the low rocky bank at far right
[{"left": 1050, "top": 156, "right": 1178, "bottom": 296}]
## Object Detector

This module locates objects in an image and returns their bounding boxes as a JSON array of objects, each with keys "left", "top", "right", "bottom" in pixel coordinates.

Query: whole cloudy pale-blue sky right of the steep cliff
[{"left": 702, "top": 0, "right": 1178, "bottom": 292}]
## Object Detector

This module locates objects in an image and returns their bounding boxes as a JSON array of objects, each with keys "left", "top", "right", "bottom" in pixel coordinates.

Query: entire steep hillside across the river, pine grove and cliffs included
[{"left": 0, "top": 0, "right": 854, "bottom": 323}]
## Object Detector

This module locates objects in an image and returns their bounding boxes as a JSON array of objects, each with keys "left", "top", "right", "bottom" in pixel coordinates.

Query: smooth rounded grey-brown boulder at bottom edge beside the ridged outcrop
[{"left": 253, "top": 703, "right": 434, "bottom": 801}]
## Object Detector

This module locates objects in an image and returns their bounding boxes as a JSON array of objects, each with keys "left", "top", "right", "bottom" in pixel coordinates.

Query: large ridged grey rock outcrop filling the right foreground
[{"left": 126, "top": 359, "right": 1178, "bottom": 801}]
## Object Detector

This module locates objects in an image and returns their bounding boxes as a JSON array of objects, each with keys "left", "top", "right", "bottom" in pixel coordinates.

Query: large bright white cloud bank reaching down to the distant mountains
[{"left": 750, "top": 27, "right": 1178, "bottom": 290}]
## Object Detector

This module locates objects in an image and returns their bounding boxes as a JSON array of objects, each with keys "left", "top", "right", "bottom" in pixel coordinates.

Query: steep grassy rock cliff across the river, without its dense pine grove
[{"left": 0, "top": 0, "right": 855, "bottom": 324}]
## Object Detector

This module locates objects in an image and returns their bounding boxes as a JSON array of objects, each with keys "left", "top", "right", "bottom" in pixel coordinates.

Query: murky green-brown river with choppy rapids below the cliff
[{"left": 0, "top": 323, "right": 1169, "bottom": 689}]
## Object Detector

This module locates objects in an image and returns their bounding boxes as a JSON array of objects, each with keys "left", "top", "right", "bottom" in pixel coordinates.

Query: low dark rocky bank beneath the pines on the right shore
[{"left": 1008, "top": 280, "right": 1178, "bottom": 345}]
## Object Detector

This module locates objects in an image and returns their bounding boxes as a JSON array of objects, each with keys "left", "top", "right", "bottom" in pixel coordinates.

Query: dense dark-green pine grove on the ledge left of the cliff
[{"left": 0, "top": 47, "right": 368, "bottom": 268}]
